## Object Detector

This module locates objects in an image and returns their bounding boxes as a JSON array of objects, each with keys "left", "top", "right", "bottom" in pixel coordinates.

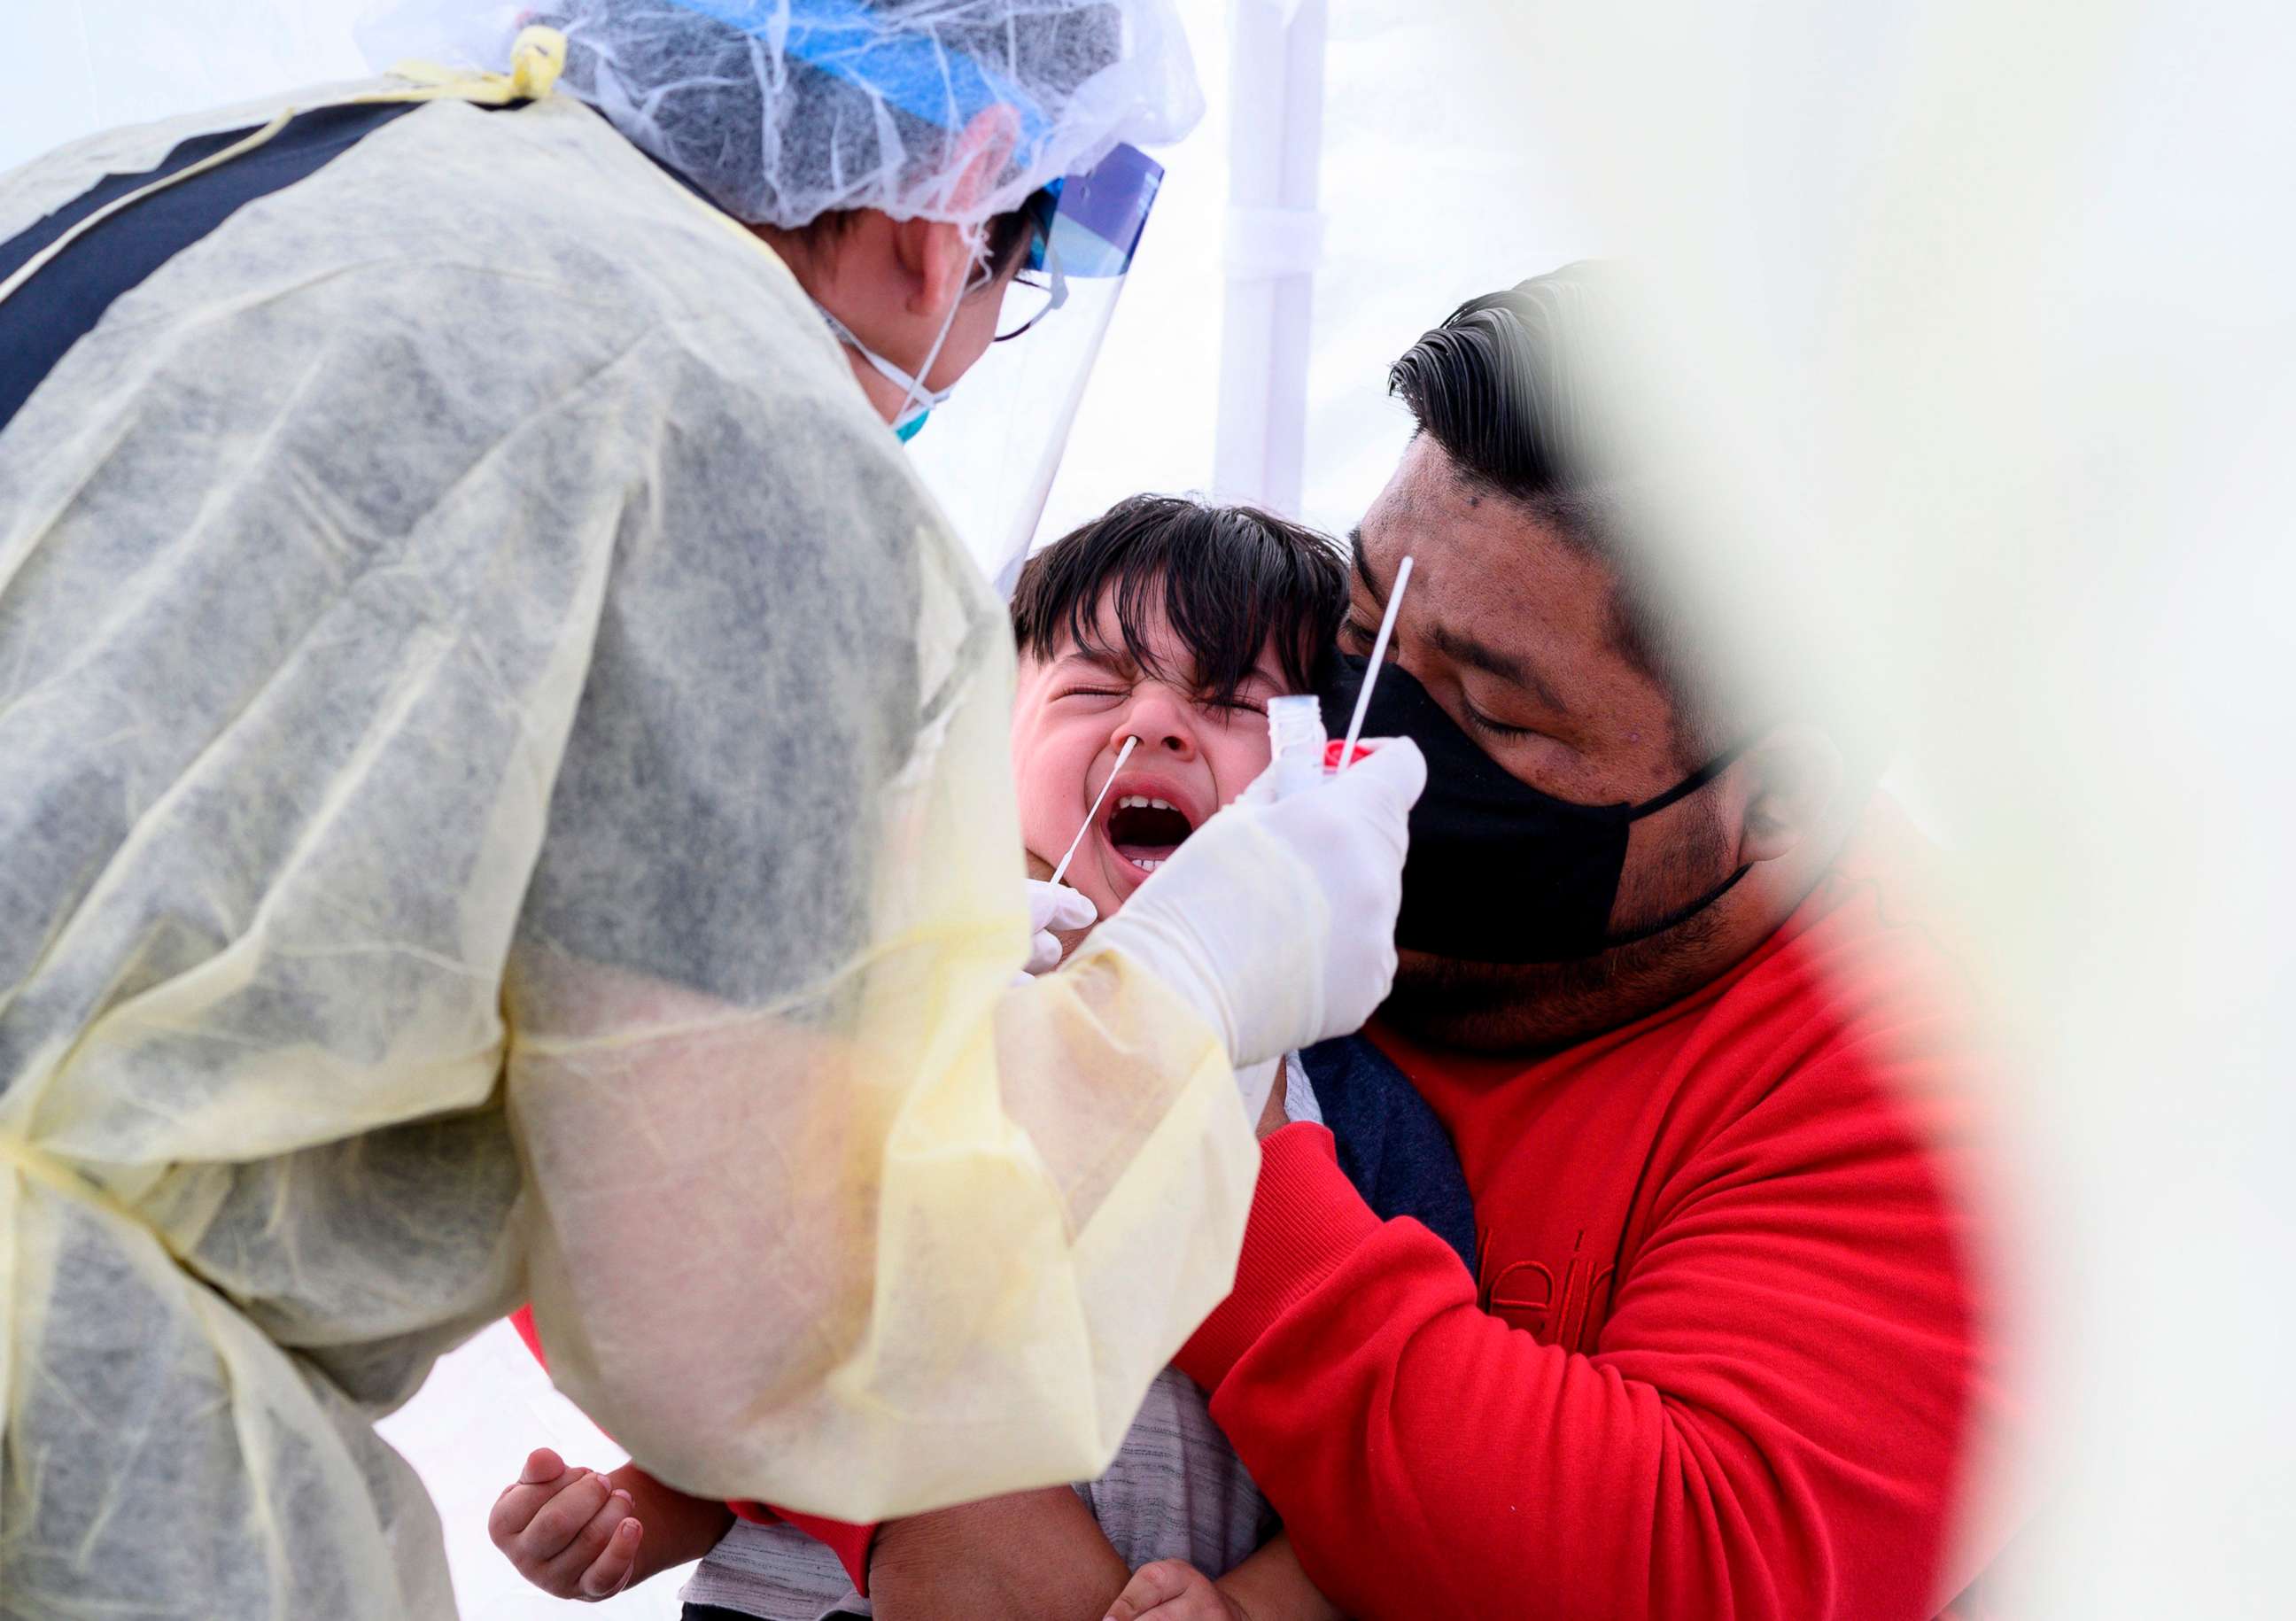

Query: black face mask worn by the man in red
[{"left": 1315, "top": 656, "right": 1749, "bottom": 962}]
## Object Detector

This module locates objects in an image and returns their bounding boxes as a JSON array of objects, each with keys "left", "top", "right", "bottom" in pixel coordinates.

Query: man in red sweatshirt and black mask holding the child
[{"left": 1118, "top": 267, "right": 2005, "bottom": 1621}]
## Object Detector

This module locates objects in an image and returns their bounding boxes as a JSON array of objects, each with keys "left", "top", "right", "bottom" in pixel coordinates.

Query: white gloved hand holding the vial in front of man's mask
[{"left": 1070, "top": 740, "right": 1428, "bottom": 1067}]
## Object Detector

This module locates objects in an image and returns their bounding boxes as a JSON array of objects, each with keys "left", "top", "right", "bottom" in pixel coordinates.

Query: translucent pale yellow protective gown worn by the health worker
[{"left": 0, "top": 69, "right": 1256, "bottom": 1621}]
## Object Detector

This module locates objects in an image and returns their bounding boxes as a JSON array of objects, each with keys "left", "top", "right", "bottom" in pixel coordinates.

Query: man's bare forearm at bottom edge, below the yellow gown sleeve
[{"left": 868, "top": 1485, "right": 1132, "bottom": 1621}]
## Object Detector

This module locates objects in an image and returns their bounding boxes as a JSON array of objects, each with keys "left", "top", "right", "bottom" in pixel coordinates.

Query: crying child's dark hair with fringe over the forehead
[{"left": 1012, "top": 496, "right": 1348, "bottom": 702}]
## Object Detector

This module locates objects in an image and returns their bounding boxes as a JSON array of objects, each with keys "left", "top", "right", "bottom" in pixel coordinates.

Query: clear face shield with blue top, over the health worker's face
[{"left": 909, "top": 147, "right": 1164, "bottom": 594}]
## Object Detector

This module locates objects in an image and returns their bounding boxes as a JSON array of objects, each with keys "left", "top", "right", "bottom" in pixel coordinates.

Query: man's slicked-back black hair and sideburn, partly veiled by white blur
[{"left": 1387, "top": 260, "right": 1715, "bottom": 751}]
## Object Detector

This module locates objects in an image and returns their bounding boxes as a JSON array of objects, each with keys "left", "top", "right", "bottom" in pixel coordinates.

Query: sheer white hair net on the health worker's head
[{"left": 363, "top": 0, "right": 1203, "bottom": 228}]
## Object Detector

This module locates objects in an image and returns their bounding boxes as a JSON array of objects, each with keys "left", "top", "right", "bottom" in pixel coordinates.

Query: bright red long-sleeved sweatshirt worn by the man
[{"left": 1180, "top": 810, "right": 2020, "bottom": 1621}]
